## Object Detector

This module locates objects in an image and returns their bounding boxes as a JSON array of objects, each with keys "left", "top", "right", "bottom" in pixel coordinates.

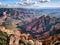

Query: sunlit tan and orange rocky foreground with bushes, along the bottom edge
[{"left": 0, "top": 27, "right": 60, "bottom": 45}]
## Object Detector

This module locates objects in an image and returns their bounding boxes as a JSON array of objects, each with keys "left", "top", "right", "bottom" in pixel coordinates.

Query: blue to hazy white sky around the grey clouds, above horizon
[{"left": 0, "top": 0, "right": 60, "bottom": 8}]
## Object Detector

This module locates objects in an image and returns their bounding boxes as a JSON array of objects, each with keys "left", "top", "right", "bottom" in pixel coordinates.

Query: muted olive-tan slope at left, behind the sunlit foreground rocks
[{"left": 2, "top": 18, "right": 17, "bottom": 29}]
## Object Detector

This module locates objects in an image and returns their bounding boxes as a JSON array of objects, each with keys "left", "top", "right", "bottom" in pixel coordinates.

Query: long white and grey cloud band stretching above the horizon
[{"left": 2, "top": 2, "right": 60, "bottom": 8}]
